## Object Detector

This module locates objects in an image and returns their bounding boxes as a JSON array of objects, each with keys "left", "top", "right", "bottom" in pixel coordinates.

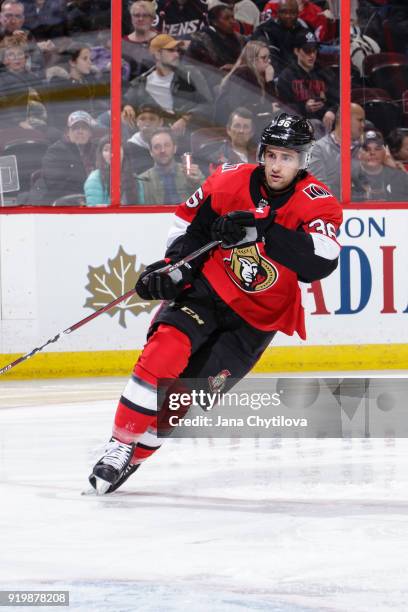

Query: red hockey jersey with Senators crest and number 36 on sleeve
[{"left": 169, "top": 164, "right": 342, "bottom": 339}]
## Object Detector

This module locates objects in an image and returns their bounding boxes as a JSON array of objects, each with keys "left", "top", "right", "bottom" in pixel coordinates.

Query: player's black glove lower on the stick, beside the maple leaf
[{"left": 135, "top": 259, "right": 193, "bottom": 300}]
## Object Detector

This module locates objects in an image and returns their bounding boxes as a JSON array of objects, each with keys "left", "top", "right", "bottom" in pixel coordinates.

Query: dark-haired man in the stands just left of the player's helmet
[{"left": 199, "top": 106, "right": 256, "bottom": 174}]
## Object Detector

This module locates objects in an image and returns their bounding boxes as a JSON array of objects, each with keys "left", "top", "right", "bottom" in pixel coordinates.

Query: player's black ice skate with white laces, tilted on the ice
[{"left": 89, "top": 438, "right": 140, "bottom": 495}]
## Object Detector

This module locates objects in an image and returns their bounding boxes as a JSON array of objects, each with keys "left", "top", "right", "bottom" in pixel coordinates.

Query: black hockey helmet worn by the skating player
[{"left": 257, "top": 113, "right": 315, "bottom": 170}]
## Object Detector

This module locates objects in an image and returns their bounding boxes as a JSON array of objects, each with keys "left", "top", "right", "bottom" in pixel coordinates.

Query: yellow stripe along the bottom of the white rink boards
[{"left": 0, "top": 344, "right": 408, "bottom": 384}]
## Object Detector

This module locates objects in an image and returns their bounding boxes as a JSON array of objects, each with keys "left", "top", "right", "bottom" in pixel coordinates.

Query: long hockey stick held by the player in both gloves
[{"left": 0, "top": 240, "right": 220, "bottom": 375}]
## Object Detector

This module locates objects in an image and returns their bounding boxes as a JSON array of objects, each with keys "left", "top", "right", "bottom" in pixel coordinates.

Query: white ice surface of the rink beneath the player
[{"left": 0, "top": 381, "right": 408, "bottom": 612}]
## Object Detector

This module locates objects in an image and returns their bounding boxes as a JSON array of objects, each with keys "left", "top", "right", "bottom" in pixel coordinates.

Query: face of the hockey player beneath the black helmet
[{"left": 265, "top": 145, "right": 300, "bottom": 191}]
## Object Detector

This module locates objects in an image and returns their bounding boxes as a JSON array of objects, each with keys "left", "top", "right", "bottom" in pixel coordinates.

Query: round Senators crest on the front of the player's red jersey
[{"left": 224, "top": 244, "right": 278, "bottom": 293}]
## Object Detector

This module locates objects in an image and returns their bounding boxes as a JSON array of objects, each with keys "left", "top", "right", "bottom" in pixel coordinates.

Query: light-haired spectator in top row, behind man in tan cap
[{"left": 122, "top": 0, "right": 157, "bottom": 79}]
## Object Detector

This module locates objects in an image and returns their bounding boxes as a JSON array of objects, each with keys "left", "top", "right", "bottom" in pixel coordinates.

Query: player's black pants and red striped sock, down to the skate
[{"left": 112, "top": 278, "right": 276, "bottom": 464}]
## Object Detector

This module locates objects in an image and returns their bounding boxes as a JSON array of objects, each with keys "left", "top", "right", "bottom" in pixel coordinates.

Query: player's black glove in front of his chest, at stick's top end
[{"left": 211, "top": 210, "right": 258, "bottom": 247}]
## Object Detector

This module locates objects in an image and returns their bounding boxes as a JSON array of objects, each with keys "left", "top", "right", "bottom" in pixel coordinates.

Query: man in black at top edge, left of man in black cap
[{"left": 252, "top": 0, "right": 311, "bottom": 74}]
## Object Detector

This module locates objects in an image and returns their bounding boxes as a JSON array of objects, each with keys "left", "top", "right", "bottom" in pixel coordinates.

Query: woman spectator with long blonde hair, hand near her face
[{"left": 215, "top": 40, "right": 286, "bottom": 133}]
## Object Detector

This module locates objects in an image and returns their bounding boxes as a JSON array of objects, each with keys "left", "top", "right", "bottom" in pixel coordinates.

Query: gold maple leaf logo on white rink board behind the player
[{"left": 84, "top": 246, "right": 158, "bottom": 327}]
